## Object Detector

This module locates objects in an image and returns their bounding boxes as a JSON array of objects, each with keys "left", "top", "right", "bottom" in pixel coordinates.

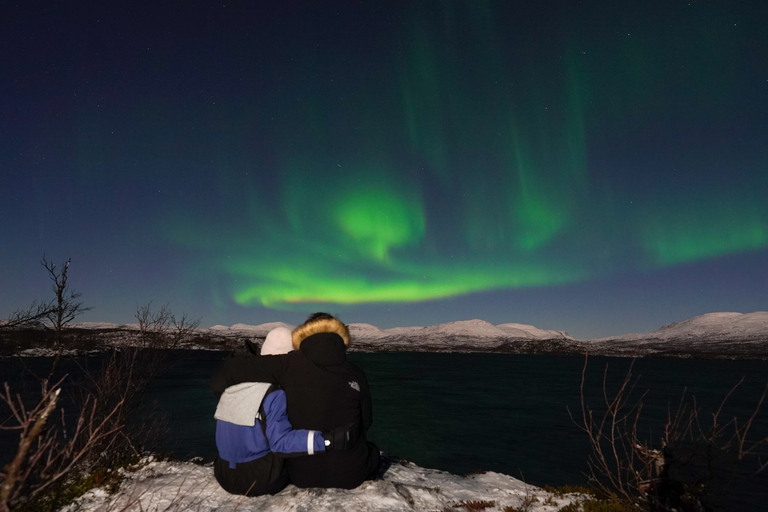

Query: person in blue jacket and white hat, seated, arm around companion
[{"left": 213, "top": 327, "right": 332, "bottom": 496}]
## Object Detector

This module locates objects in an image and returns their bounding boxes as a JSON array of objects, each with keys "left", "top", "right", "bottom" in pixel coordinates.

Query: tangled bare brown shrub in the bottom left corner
[{"left": 0, "top": 347, "right": 168, "bottom": 512}]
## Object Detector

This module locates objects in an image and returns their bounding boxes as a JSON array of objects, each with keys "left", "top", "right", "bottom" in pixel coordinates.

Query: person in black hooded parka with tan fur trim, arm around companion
[{"left": 211, "top": 313, "right": 380, "bottom": 489}]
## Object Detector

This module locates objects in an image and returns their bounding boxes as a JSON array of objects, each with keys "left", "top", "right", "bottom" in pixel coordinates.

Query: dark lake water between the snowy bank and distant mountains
[{"left": 0, "top": 351, "right": 768, "bottom": 510}]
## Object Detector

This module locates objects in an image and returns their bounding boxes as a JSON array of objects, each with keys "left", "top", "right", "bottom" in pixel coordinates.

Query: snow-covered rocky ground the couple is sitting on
[{"left": 60, "top": 461, "right": 579, "bottom": 512}]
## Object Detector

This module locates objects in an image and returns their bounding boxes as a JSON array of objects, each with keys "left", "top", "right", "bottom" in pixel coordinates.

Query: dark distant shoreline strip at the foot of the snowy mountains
[{"left": 0, "top": 324, "right": 768, "bottom": 360}]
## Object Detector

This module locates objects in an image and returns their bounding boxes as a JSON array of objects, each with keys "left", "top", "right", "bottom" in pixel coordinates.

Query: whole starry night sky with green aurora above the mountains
[{"left": 0, "top": 0, "right": 768, "bottom": 338}]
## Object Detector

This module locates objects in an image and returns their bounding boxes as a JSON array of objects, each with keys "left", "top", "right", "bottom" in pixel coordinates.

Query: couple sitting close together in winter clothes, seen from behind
[{"left": 211, "top": 313, "right": 380, "bottom": 496}]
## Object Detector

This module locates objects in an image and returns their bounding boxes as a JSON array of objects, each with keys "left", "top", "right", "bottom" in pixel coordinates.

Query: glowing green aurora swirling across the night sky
[{"left": 158, "top": 2, "right": 768, "bottom": 309}]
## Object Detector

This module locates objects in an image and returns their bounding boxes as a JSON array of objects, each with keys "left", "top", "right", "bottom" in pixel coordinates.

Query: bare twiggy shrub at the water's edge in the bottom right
[{"left": 568, "top": 357, "right": 768, "bottom": 512}]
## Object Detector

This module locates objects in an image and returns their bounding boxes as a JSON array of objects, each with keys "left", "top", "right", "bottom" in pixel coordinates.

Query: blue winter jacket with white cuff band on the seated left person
[{"left": 216, "top": 390, "right": 325, "bottom": 468}]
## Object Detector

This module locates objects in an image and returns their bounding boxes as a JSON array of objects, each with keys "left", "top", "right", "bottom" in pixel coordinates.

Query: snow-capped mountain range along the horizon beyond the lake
[{"left": 7, "top": 311, "right": 768, "bottom": 359}]
